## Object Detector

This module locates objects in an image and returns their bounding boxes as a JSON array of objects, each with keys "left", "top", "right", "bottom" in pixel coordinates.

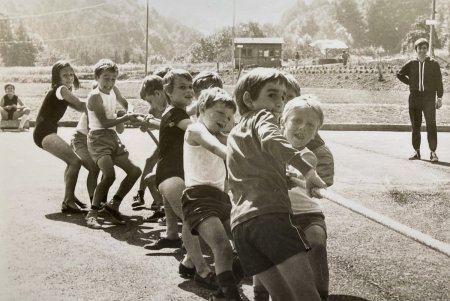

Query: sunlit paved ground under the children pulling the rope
[{"left": 0, "top": 128, "right": 450, "bottom": 301}]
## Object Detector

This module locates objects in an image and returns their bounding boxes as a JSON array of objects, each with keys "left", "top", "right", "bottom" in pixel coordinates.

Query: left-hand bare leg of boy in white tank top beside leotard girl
[{"left": 92, "top": 156, "right": 116, "bottom": 208}]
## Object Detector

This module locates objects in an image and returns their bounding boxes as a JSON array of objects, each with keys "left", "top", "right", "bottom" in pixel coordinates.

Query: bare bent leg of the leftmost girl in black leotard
[{"left": 42, "top": 134, "right": 81, "bottom": 208}]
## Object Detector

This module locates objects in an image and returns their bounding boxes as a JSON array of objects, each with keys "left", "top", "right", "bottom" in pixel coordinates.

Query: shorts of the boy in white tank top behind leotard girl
[{"left": 88, "top": 129, "right": 128, "bottom": 163}]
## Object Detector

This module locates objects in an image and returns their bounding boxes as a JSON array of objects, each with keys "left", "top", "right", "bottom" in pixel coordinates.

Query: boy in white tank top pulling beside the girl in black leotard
[{"left": 86, "top": 59, "right": 141, "bottom": 229}]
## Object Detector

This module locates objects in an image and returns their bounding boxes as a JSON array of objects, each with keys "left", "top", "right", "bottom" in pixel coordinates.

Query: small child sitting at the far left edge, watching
[{"left": 0, "top": 84, "right": 30, "bottom": 131}]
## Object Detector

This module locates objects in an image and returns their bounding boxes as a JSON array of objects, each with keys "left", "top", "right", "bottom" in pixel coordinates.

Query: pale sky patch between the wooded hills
[{"left": 149, "top": 0, "right": 296, "bottom": 34}]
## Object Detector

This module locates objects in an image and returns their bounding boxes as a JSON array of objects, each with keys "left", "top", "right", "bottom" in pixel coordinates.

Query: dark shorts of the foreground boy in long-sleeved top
[{"left": 233, "top": 213, "right": 310, "bottom": 276}]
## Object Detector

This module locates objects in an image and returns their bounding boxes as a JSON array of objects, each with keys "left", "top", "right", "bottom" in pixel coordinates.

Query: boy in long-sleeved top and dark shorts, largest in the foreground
[{"left": 227, "top": 68, "right": 326, "bottom": 301}]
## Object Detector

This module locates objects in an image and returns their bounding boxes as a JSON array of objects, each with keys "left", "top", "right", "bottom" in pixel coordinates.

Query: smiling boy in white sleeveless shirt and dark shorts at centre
[{"left": 181, "top": 88, "right": 241, "bottom": 300}]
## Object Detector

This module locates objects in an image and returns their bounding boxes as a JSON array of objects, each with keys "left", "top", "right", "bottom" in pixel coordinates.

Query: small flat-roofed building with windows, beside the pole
[{"left": 234, "top": 38, "right": 284, "bottom": 68}]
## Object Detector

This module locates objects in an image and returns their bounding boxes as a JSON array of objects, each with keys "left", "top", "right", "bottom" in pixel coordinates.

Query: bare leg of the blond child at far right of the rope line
[{"left": 304, "top": 225, "right": 329, "bottom": 300}]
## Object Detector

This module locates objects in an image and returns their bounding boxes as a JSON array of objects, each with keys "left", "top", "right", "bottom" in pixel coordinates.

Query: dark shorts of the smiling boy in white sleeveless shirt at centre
[{"left": 181, "top": 185, "right": 231, "bottom": 235}]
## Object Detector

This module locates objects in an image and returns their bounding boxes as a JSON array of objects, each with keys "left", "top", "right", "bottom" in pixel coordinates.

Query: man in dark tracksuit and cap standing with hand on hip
[{"left": 397, "top": 38, "right": 444, "bottom": 162}]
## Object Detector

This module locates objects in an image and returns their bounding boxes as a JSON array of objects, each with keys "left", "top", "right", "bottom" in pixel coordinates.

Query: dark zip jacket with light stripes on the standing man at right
[{"left": 397, "top": 57, "right": 444, "bottom": 98}]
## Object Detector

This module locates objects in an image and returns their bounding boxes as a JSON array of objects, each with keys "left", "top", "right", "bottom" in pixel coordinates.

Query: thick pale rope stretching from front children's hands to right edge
[{"left": 314, "top": 185, "right": 450, "bottom": 257}]
